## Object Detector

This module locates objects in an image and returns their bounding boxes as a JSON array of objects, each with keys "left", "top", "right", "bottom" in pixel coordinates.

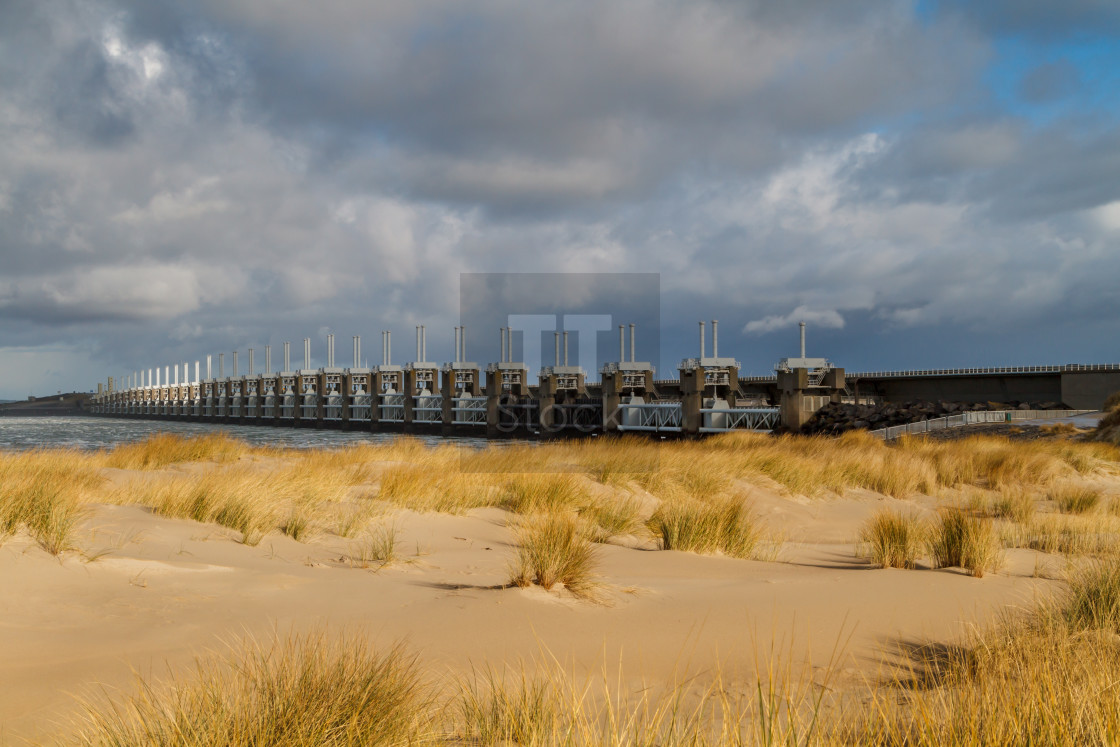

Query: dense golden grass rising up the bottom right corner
[{"left": 851, "top": 559, "right": 1120, "bottom": 747}]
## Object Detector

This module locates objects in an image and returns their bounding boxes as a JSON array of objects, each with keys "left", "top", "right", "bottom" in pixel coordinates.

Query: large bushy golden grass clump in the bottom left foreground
[{"left": 81, "top": 634, "right": 431, "bottom": 747}]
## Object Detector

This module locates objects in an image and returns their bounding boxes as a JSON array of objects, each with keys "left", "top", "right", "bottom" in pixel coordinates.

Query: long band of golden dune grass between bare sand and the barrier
[{"left": 0, "top": 432, "right": 1120, "bottom": 555}]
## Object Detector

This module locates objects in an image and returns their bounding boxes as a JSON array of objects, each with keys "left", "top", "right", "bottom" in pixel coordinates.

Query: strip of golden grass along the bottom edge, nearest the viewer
[{"left": 70, "top": 559, "right": 1120, "bottom": 747}]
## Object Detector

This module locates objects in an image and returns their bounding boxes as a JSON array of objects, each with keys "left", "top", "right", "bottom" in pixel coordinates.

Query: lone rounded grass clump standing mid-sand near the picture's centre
[{"left": 510, "top": 514, "right": 596, "bottom": 596}]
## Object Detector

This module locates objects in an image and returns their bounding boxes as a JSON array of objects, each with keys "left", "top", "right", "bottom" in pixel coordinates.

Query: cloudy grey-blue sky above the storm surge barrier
[{"left": 0, "top": 0, "right": 1120, "bottom": 399}]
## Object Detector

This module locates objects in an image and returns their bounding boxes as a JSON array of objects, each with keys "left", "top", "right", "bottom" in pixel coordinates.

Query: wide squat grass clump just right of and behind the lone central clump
[{"left": 648, "top": 497, "right": 760, "bottom": 558}]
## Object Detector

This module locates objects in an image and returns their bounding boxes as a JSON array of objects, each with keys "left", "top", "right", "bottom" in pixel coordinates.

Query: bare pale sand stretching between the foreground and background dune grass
[{"left": 0, "top": 473, "right": 1060, "bottom": 744}]
